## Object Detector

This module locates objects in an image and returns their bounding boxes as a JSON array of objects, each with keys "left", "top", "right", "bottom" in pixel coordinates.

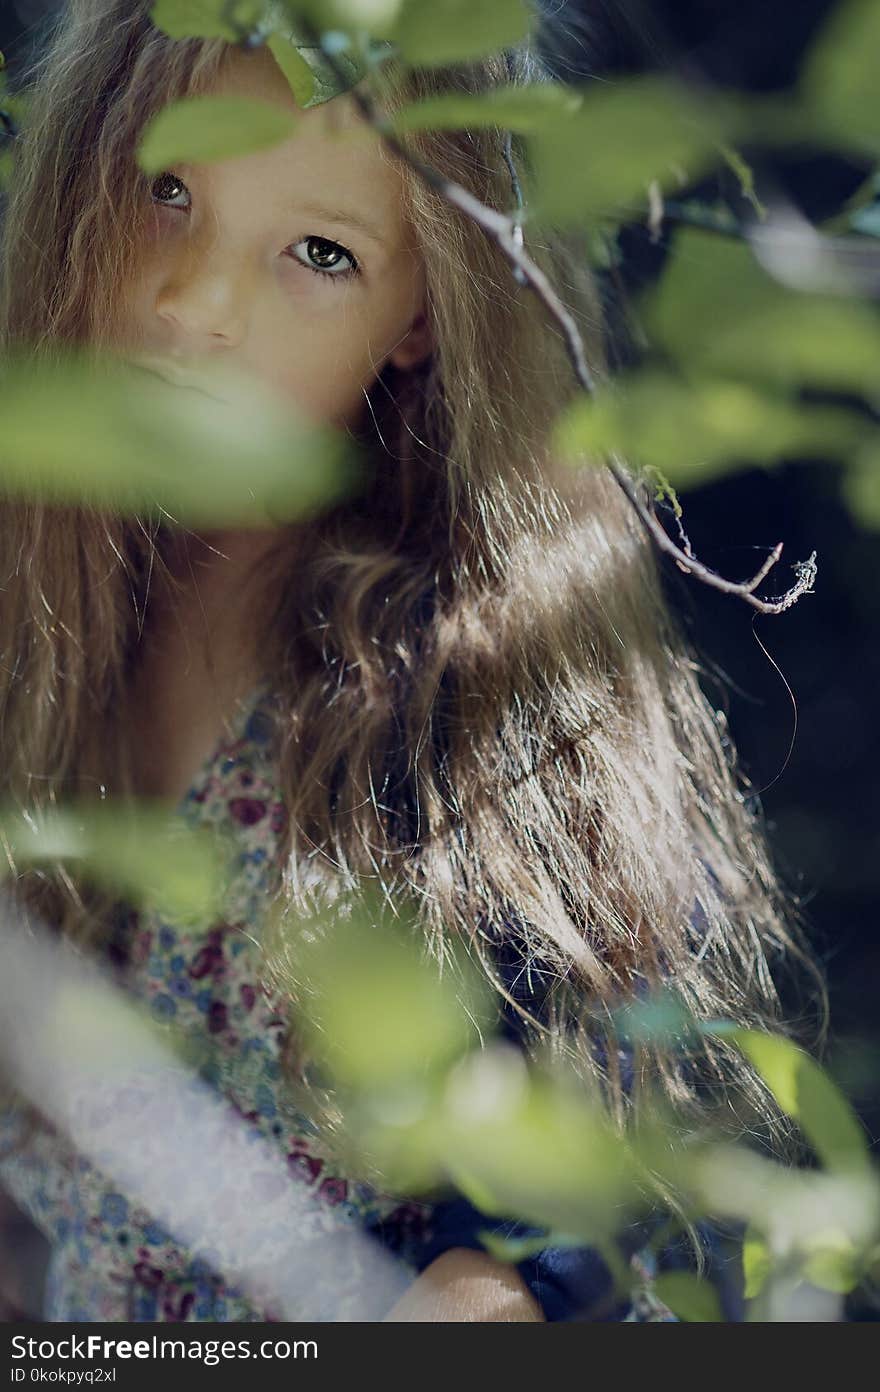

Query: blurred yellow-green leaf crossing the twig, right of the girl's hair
[{"left": 553, "top": 369, "right": 867, "bottom": 487}]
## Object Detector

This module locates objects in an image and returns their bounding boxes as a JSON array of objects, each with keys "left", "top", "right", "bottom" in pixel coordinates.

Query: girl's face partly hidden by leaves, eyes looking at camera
[{"left": 116, "top": 49, "right": 432, "bottom": 427}]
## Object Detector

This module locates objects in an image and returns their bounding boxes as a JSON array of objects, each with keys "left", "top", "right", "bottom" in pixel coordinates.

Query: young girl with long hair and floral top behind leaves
[{"left": 0, "top": 0, "right": 824, "bottom": 1321}]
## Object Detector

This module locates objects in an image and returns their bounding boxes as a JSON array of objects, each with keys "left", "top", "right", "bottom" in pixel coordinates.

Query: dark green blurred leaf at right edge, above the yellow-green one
[{"left": 642, "top": 228, "right": 880, "bottom": 398}]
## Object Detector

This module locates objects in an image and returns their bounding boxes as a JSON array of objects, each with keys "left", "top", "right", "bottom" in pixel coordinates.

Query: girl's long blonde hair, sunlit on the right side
[{"left": 0, "top": 0, "right": 824, "bottom": 1185}]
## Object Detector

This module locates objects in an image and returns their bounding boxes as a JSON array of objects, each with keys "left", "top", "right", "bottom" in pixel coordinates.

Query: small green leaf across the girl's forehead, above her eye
[{"left": 138, "top": 96, "right": 297, "bottom": 174}]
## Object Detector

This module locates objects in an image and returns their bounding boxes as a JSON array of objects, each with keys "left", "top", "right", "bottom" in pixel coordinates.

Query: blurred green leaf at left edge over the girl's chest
[{"left": 0, "top": 802, "right": 231, "bottom": 924}]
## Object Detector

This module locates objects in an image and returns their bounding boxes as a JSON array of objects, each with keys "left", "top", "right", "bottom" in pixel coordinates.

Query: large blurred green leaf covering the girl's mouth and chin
[{"left": 0, "top": 352, "right": 358, "bottom": 526}]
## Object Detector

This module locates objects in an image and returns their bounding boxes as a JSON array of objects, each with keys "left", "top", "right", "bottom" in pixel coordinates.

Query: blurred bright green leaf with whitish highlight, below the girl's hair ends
[{"left": 346, "top": 1035, "right": 643, "bottom": 1246}]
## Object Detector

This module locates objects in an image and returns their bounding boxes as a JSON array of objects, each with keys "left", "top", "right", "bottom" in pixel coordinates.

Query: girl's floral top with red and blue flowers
[{"left": 0, "top": 683, "right": 704, "bottom": 1322}]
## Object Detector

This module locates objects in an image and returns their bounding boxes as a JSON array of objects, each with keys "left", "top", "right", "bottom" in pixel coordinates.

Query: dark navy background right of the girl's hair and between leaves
[{"left": 0, "top": 0, "right": 880, "bottom": 1318}]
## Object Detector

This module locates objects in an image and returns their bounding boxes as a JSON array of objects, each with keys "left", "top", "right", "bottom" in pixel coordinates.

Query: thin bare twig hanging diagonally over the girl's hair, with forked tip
[{"left": 270, "top": 14, "right": 816, "bottom": 614}]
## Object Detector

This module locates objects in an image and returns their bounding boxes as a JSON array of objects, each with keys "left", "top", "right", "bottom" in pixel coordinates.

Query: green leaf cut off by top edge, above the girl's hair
[{"left": 388, "top": 0, "right": 533, "bottom": 67}]
